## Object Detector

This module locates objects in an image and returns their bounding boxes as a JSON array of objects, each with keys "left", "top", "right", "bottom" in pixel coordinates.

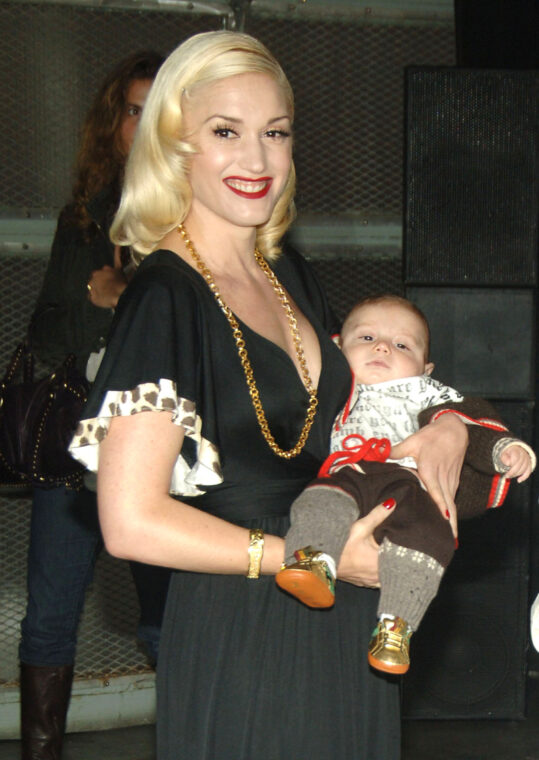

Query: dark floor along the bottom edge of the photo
[{"left": 0, "top": 673, "right": 539, "bottom": 760}]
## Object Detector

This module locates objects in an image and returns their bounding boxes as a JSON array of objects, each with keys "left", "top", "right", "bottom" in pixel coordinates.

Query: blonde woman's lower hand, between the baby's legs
[{"left": 337, "top": 499, "right": 395, "bottom": 588}]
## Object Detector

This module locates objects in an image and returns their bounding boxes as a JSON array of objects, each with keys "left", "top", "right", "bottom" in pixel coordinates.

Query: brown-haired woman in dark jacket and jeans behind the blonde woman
[{"left": 19, "top": 51, "right": 169, "bottom": 760}]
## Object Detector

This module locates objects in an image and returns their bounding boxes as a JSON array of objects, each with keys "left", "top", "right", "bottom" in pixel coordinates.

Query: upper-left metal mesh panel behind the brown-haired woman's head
[{"left": 0, "top": 3, "right": 221, "bottom": 214}]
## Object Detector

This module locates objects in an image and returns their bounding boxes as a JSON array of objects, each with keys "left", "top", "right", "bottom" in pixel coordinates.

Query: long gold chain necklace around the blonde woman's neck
[{"left": 178, "top": 224, "right": 318, "bottom": 459}]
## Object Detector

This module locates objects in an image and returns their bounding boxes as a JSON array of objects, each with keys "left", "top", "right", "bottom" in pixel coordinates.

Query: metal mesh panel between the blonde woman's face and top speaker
[{"left": 249, "top": 15, "right": 454, "bottom": 217}]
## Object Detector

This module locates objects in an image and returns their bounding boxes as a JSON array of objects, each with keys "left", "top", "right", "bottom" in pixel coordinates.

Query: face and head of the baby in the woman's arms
[{"left": 341, "top": 302, "right": 434, "bottom": 385}]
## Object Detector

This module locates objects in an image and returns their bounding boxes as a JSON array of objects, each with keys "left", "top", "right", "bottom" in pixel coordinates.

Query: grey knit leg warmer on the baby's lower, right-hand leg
[{"left": 378, "top": 538, "right": 444, "bottom": 631}]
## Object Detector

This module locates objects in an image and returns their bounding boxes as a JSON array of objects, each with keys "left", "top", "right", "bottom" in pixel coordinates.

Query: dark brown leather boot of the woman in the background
[{"left": 21, "top": 663, "right": 73, "bottom": 760}]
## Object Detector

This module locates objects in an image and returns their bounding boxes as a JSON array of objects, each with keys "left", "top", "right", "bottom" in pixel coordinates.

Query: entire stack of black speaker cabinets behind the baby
[{"left": 403, "top": 68, "right": 539, "bottom": 719}]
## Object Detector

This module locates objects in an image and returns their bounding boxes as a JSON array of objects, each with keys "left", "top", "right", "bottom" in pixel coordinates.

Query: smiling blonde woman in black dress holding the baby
[{"left": 72, "top": 32, "right": 466, "bottom": 760}]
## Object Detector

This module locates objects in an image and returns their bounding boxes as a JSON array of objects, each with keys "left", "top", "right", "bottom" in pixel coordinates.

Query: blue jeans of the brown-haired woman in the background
[{"left": 19, "top": 487, "right": 170, "bottom": 665}]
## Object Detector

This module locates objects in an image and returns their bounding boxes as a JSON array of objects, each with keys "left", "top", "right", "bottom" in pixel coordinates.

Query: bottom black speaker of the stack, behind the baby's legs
[{"left": 403, "top": 402, "right": 533, "bottom": 719}]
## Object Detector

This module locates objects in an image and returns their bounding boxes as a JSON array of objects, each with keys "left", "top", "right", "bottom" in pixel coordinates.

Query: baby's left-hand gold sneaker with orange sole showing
[{"left": 275, "top": 546, "right": 335, "bottom": 608}]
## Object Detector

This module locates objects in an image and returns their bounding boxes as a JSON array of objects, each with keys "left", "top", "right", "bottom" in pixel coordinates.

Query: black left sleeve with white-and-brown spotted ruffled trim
[{"left": 70, "top": 252, "right": 223, "bottom": 496}]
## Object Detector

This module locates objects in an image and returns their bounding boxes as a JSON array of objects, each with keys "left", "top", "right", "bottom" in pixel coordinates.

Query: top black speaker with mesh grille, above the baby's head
[{"left": 404, "top": 68, "right": 539, "bottom": 287}]
